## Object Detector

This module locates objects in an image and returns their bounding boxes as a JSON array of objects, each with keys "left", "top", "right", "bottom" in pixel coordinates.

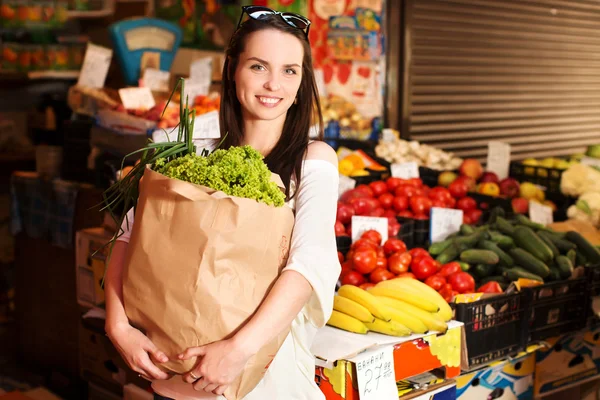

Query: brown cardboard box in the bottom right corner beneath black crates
[{"left": 534, "top": 323, "right": 600, "bottom": 397}]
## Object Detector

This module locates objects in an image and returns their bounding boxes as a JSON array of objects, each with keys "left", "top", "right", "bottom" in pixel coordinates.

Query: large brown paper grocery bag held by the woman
[{"left": 123, "top": 168, "right": 294, "bottom": 400}]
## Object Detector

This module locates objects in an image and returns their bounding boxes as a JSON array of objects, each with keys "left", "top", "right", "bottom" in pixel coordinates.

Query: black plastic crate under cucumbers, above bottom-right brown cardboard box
[{"left": 523, "top": 277, "right": 590, "bottom": 341}]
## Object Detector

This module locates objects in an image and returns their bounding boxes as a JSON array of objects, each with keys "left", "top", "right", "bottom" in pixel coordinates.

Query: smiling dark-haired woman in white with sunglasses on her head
[{"left": 105, "top": 7, "right": 340, "bottom": 400}]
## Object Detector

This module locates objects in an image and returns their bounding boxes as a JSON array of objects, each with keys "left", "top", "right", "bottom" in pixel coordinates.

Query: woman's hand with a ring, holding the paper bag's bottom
[{"left": 178, "top": 337, "right": 254, "bottom": 395}]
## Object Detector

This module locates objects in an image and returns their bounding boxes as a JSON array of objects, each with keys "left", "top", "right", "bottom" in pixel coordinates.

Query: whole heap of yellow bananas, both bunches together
[{"left": 327, "top": 278, "right": 452, "bottom": 336}]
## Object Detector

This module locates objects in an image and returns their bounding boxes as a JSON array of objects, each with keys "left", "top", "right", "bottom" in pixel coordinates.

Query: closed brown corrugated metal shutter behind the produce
[{"left": 402, "top": 0, "right": 600, "bottom": 160}]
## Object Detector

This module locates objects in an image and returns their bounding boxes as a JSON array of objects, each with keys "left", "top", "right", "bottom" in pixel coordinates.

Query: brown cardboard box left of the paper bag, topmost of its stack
[{"left": 75, "top": 228, "right": 112, "bottom": 308}]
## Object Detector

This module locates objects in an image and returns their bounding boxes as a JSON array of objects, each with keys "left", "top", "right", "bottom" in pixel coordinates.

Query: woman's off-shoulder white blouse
[{"left": 117, "top": 160, "right": 341, "bottom": 400}]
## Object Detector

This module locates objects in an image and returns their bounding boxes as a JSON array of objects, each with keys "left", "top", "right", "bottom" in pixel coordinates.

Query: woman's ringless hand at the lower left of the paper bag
[{"left": 107, "top": 323, "right": 170, "bottom": 380}]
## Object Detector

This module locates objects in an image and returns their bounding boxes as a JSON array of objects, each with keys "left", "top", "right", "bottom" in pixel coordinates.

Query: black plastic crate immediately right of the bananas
[{"left": 455, "top": 293, "right": 528, "bottom": 369}]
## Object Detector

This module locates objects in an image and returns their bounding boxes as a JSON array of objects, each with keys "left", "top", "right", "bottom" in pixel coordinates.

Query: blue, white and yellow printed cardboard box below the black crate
[{"left": 456, "top": 350, "right": 535, "bottom": 400}]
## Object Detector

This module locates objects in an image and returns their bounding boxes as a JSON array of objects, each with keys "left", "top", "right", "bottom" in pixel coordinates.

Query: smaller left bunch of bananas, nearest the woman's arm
[{"left": 327, "top": 285, "right": 416, "bottom": 336}]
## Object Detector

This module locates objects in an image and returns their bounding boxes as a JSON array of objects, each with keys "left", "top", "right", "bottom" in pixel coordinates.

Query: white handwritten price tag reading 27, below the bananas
[{"left": 352, "top": 346, "right": 398, "bottom": 400}]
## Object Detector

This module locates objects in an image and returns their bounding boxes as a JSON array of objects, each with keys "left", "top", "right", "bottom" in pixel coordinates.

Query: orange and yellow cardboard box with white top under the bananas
[{"left": 312, "top": 321, "right": 462, "bottom": 400}]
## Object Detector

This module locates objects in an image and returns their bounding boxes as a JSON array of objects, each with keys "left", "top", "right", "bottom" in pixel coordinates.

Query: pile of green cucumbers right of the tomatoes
[{"left": 429, "top": 208, "right": 600, "bottom": 288}]
